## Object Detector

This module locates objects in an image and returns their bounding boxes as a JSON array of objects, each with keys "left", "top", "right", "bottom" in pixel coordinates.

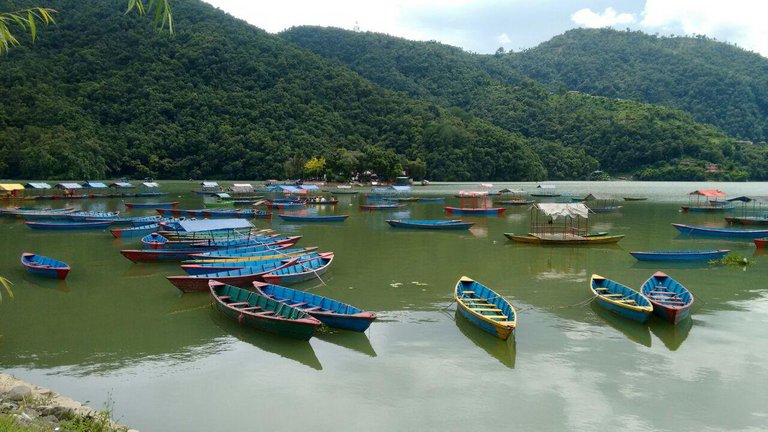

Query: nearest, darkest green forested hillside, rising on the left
[{"left": 0, "top": 0, "right": 546, "bottom": 180}]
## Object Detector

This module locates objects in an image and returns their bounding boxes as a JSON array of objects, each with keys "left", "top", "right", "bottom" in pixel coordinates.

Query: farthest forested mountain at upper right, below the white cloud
[{"left": 504, "top": 29, "right": 768, "bottom": 141}]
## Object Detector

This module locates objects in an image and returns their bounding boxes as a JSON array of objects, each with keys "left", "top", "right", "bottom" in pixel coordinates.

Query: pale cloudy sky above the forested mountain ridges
[{"left": 205, "top": 0, "right": 768, "bottom": 57}]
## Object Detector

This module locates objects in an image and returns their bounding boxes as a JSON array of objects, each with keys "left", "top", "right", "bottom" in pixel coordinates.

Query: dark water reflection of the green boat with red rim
[{"left": 210, "top": 308, "right": 323, "bottom": 370}]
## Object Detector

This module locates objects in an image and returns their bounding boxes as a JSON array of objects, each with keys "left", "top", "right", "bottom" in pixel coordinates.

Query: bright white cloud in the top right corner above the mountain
[{"left": 640, "top": 0, "right": 768, "bottom": 56}]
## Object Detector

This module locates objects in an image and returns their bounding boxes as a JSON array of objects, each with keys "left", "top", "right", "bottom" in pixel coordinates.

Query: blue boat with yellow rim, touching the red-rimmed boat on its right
[{"left": 589, "top": 274, "right": 653, "bottom": 323}]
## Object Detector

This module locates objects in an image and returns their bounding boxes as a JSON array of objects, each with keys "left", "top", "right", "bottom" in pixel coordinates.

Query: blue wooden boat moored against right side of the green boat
[{"left": 253, "top": 282, "right": 376, "bottom": 332}]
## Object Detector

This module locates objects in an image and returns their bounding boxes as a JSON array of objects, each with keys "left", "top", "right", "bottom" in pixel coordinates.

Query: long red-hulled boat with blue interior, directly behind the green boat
[{"left": 166, "top": 257, "right": 298, "bottom": 293}]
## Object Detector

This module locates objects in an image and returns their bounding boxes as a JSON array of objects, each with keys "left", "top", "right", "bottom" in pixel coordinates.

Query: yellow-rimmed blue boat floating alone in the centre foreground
[{"left": 453, "top": 276, "right": 517, "bottom": 340}]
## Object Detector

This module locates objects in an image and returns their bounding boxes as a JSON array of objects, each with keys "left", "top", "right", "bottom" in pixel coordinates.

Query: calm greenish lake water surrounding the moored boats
[{"left": 0, "top": 182, "right": 768, "bottom": 431}]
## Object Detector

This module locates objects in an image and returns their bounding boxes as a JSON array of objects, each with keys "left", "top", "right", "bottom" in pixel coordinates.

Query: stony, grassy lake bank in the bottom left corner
[{"left": 0, "top": 372, "right": 138, "bottom": 432}]
